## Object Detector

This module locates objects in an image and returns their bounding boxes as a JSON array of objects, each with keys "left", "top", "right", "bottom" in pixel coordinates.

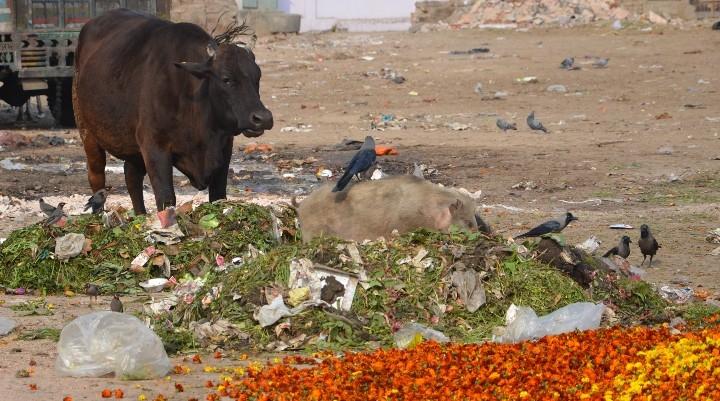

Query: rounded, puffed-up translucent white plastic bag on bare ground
[{"left": 55, "top": 311, "right": 170, "bottom": 380}]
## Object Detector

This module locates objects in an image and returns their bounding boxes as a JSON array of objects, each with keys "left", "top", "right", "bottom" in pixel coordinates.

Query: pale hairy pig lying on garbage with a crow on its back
[{"left": 293, "top": 175, "right": 489, "bottom": 242}]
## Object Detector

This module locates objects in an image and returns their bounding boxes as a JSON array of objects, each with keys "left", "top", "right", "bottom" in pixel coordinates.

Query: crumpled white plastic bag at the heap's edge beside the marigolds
[{"left": 495, "top": 302, "right": 605, "bottom": 343}]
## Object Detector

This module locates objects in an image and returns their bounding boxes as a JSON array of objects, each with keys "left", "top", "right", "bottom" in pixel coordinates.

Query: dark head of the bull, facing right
[{"left": 175, "top": 41, "right": 273, "bottom": 137}]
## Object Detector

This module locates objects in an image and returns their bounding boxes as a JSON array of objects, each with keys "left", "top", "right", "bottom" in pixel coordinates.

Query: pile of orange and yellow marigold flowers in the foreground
[{"left": 208, "top": 326, "right": 720, "bottom": 401}]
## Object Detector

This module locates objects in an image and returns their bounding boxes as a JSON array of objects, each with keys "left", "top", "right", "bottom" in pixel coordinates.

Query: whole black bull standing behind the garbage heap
[{"left": 73, "top": 10, "right": 273, "bottom": 214}]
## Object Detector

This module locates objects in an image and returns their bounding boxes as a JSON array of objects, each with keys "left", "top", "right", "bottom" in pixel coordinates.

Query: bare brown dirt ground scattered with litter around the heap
[{"left": 0, "top": 23, "right": 720, "bottom": 400}]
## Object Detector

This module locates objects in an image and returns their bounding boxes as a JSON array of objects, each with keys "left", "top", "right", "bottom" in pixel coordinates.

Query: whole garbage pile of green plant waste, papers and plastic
[{"left": 0, "top": 201, "right": 708, "bottom": 354}]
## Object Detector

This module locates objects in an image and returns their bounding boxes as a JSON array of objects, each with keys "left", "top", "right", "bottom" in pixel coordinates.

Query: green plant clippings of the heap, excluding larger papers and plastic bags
[{"left": 0, "top": 201, "right": 666, "bottom": 351}]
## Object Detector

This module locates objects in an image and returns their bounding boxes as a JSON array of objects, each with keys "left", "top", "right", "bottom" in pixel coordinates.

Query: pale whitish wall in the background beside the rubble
[{"left": 278, "top": 0, "right": 416, "bottom": 32}]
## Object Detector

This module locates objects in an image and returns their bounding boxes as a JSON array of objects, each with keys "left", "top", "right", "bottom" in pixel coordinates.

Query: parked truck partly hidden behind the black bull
[{"left": 0, "top": 0, "right": 170, "bottom": 127}]
